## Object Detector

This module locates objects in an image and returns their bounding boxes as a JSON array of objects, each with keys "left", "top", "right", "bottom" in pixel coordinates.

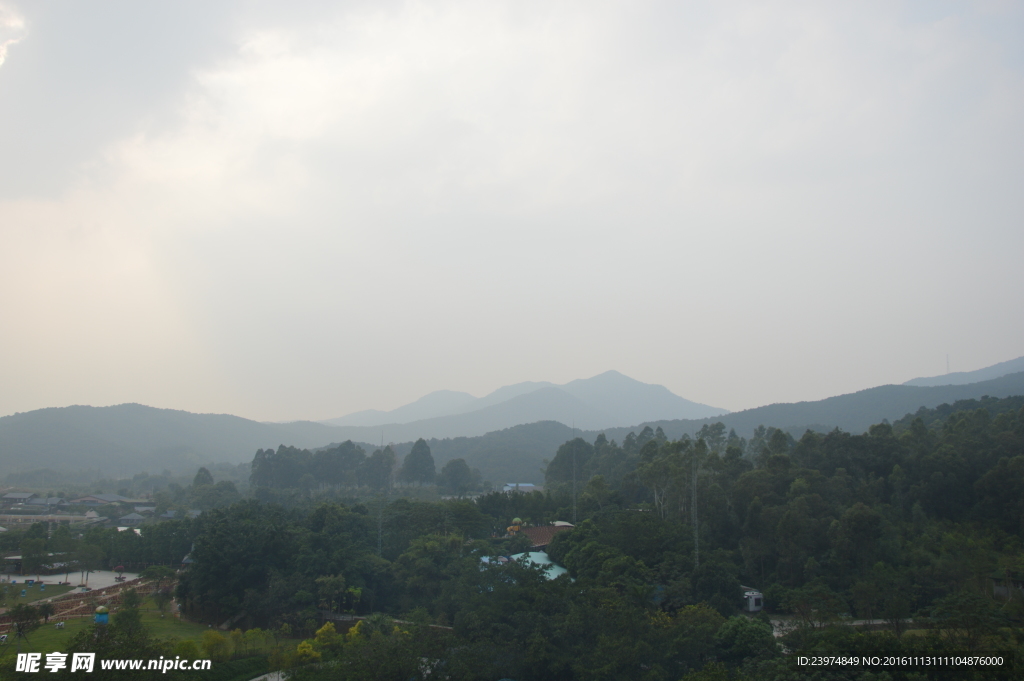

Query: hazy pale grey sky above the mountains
[{"left": 0, "top": 0, "right": 1024, "bottom": 420}]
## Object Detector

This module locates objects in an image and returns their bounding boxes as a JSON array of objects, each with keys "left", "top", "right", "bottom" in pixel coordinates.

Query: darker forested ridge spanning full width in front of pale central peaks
[{"left": 0, "top": 373, "right": 1024, "bottom": 482}]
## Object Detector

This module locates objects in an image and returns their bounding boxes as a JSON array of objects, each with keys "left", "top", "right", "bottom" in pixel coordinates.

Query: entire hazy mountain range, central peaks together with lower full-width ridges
[{"left": 0, "top": 363, "right": 1024, "bottom": 482}]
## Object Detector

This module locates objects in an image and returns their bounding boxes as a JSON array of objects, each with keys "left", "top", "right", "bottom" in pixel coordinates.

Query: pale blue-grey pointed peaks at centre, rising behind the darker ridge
[{"left": 321, "top": 371, "right": 728, "bottom": 430}]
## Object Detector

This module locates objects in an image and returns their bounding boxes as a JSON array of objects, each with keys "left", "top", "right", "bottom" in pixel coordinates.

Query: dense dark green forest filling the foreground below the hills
[{"left": 0, "top": 397, "right": 1024, "bottom": 681}]
